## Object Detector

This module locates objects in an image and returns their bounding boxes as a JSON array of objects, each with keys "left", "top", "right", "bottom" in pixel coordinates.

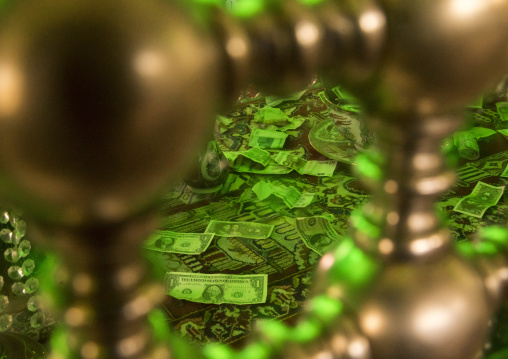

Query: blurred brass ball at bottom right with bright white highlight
[{"left": 359, "top": 256, "right": 490, "bottom": 359}]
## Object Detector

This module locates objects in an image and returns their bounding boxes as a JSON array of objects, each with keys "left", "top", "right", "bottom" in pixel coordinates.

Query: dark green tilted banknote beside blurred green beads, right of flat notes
[{"left": 296, "top": 217, "right": 341, "bottom": 255}]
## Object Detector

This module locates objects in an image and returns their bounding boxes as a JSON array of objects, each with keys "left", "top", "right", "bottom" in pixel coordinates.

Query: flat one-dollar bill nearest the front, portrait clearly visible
[{"left": 164, "top": 272, "right": 268, "bottom": 305}]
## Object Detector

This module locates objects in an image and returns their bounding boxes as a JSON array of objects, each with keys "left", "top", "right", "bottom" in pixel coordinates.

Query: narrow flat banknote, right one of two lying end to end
[{"left": 205, "top": 220, "right": 273, "bottom": 239}]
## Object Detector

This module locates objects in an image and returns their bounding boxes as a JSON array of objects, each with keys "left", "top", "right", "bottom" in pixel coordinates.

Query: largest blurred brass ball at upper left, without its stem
[{"left": 0, "top": 0, "right": 220, "bottom": 226}]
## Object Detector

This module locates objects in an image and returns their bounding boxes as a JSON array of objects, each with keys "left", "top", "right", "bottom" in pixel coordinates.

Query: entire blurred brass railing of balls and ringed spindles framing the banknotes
[{"left": 0, "top": 0, "right": 508, "bottom": 359}]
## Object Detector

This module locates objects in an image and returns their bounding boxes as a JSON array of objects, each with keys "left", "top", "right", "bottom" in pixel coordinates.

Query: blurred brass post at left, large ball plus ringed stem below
[{"left": 0, "top": 0, "right": 221, "bottom": 359}]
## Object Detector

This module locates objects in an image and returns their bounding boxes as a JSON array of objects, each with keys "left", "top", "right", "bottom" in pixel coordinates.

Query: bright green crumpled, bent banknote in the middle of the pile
[{"left": 252, "top": 181, "right": 316, "bottom": 208}]
